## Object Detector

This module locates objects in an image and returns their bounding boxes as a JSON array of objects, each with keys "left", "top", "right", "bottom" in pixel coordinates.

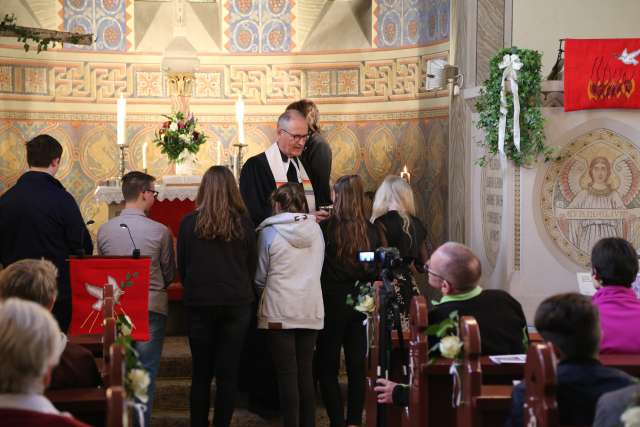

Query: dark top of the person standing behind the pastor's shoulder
[{"left": 300, "top": 132, "right": 333, "bottom": 209}]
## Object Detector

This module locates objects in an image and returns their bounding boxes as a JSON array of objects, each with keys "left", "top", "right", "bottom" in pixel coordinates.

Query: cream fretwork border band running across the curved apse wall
[{"left": 0, "top": 53, "right": 447, "bottom": 105}]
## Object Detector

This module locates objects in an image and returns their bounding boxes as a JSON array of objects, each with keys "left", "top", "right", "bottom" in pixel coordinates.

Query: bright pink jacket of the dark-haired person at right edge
[{"left": 591, "top": 286, "right": 640, "bottom": 354}]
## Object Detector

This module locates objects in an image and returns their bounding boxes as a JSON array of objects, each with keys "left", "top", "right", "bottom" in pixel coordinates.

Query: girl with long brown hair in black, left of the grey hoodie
[{"left": 178, "top": 166, "right": 257, "bottom": 427}]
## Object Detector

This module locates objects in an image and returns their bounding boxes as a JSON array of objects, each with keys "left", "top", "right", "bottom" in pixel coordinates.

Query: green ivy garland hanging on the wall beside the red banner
[{"left": 476, "top": 47, "right": 553, "bottom": 167}]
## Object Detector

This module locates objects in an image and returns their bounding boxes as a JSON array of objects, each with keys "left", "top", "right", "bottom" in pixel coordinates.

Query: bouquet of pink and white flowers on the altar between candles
[{"left": 153, "top": 111, "right": 207, "bottom": 163}]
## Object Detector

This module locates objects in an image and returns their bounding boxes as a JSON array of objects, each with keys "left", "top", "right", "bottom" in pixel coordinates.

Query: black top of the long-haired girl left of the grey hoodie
[{"left": 178, "top": 211, "right": 258, "bottom": 306}]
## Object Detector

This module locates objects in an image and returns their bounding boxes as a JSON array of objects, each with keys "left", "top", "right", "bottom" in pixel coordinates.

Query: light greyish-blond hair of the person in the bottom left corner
[{"left": 0, "top": 298, "right": 66, "bottom": 394}]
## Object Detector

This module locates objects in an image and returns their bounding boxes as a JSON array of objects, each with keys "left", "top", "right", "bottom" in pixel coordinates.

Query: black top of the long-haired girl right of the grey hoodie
[{"left": 320, "top": 218, "right": 379, "bottom": 297}]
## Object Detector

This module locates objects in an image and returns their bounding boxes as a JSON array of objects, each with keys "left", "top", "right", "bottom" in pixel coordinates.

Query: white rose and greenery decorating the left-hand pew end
[{"left": 115, "top": 314, "right": 150, "bottom": 403}]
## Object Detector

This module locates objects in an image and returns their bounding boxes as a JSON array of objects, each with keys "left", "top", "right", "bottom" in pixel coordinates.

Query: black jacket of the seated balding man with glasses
[{"left": 429, "top": 289, "right": 528, "bottom": 355}]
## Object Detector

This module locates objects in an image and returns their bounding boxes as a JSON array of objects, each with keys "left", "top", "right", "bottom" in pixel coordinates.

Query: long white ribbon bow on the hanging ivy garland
[{"left": 498, "top": 54, "right": 522, "bottom": 157}]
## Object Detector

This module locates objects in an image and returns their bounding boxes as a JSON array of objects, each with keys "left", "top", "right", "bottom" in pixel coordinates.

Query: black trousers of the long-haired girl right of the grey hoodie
[{"left": 316, "top": 295, "right": 367, "bottom": 427}]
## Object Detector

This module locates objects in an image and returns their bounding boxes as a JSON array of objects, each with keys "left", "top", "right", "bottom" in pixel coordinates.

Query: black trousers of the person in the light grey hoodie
[{"left": 267, "top": 329, "right": 318, "bottom": 427}]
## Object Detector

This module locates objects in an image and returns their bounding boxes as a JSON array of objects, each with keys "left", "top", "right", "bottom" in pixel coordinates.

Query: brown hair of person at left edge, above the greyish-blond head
[{"left": 0, "top": 259, "right": 58, "bottom": 308}]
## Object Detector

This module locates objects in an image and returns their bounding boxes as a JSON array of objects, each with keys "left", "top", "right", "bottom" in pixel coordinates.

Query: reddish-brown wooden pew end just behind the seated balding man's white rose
[{"left": 456, "top": 316, "right": 512, "bottom": 427}]
